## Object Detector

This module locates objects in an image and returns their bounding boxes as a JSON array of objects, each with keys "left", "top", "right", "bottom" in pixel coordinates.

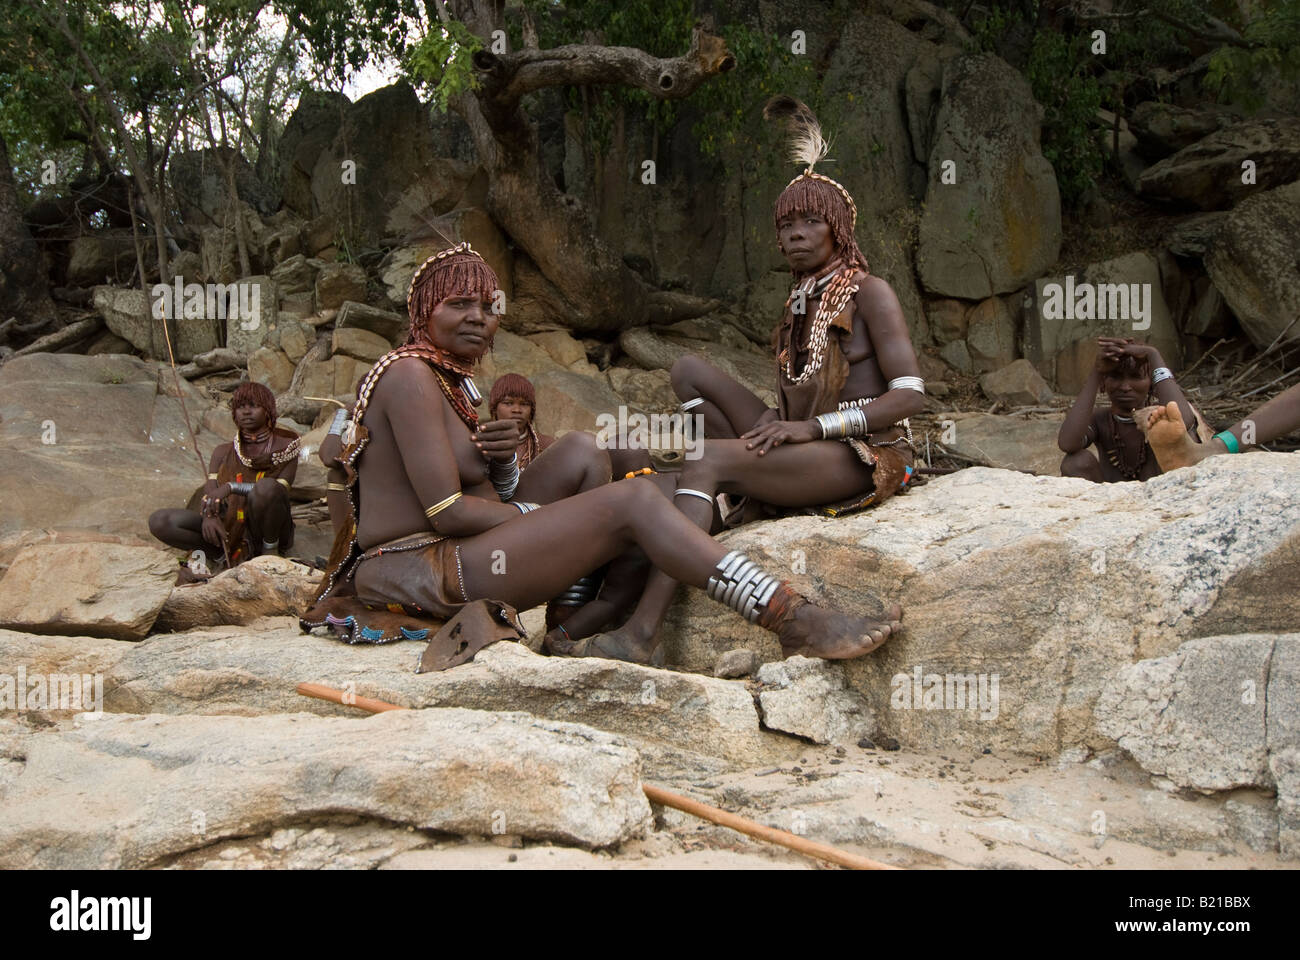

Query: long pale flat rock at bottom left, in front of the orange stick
[{"left": 0, "top": 710, "right": 650, "bottom": 869}]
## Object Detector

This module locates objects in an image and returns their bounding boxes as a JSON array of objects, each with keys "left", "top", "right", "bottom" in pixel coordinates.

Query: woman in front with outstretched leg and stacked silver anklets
[{"left": 303, "top": 243, "right": 898, "bottom": 658}]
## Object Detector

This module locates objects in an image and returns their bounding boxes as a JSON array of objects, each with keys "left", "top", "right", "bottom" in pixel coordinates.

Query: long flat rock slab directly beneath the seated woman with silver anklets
[{"left": 105, "top": 620, "right": 790, "bottom": 773}]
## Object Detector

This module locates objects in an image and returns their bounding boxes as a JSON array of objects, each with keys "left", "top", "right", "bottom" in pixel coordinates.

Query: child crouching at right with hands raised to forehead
[{"left": 1057, "top": 337, "right": 1200, "bottom": 484}]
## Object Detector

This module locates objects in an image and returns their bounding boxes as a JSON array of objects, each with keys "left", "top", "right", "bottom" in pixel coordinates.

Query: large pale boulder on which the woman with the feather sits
[{"left": 663, "top": 454, "right": 1300, "bottom": 756}]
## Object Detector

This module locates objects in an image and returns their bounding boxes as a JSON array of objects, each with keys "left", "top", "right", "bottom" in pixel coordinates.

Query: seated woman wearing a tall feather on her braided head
[{"left": 561, "top": 96, "right": 924, "bottom": 661}]
